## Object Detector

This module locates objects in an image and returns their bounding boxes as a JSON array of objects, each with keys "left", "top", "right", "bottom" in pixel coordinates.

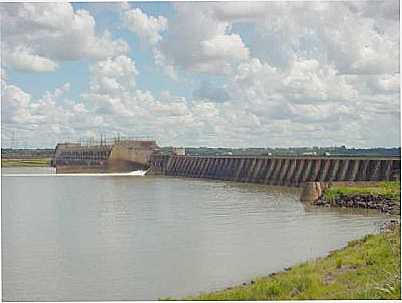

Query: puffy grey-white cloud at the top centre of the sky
[{"left": 160, "top": 3, "right": 249, "bottom": 74}]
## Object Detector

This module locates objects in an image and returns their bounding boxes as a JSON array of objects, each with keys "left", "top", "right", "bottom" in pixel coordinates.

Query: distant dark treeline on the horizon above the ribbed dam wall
[{"left": 162, "top": 146, "right": 401, "bottom": 156}]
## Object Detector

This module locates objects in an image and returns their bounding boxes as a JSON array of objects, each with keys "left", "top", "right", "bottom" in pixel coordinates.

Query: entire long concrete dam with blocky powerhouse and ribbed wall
[{"left": 53, "top": 138, "right": 401, "bottom": 200}]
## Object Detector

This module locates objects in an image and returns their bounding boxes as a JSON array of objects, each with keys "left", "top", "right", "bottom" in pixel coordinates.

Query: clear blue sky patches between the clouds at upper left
[{"left": 8, "top": 2, "right": 187, "bottom": 98}]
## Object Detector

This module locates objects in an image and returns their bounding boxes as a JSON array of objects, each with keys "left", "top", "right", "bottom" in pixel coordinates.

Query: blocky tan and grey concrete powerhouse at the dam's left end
[{"left": 54, "top": 140, "right": 159, "bottom": 173}]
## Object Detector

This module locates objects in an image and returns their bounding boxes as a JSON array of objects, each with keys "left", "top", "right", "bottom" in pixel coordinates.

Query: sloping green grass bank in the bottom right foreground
[{"left": 184, "top": 225, "right": 401, "bottom": 300}]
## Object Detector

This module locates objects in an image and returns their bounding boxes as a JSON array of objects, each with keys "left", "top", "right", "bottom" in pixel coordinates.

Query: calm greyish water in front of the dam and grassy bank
[{"left": 2, "top": 168, "right": 385, "bottom": 301}]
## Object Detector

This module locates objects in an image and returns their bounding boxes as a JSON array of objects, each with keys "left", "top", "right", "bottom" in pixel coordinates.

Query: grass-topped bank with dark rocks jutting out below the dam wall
[{"left": 313, "top": 181, "right": 401, "bottom": 215}]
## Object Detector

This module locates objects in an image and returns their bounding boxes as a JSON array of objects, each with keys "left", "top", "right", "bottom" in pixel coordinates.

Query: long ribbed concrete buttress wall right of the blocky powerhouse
[{"left": 151, "top": 155, "right": 401, "bottom": 186}]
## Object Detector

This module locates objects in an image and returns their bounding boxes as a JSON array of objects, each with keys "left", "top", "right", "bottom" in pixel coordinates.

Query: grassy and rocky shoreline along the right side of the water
[{"left": 178, "top": 181, "right": 401, "bottom": 300}]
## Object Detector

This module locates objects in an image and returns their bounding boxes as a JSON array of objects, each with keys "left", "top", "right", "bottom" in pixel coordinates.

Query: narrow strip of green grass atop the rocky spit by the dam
[{"left": 324, "top": 181, "right": 401, "bottom": 203}]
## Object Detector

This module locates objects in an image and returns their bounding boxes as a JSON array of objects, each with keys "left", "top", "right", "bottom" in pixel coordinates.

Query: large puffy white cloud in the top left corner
[{"left": 0, "top": 3, "right": 128, "bottom": 72}]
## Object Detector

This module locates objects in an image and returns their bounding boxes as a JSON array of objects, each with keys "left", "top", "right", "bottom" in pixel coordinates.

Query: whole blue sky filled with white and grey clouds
[{"left": 0, "top": 0, "right": 400, "bottom": 147}]
